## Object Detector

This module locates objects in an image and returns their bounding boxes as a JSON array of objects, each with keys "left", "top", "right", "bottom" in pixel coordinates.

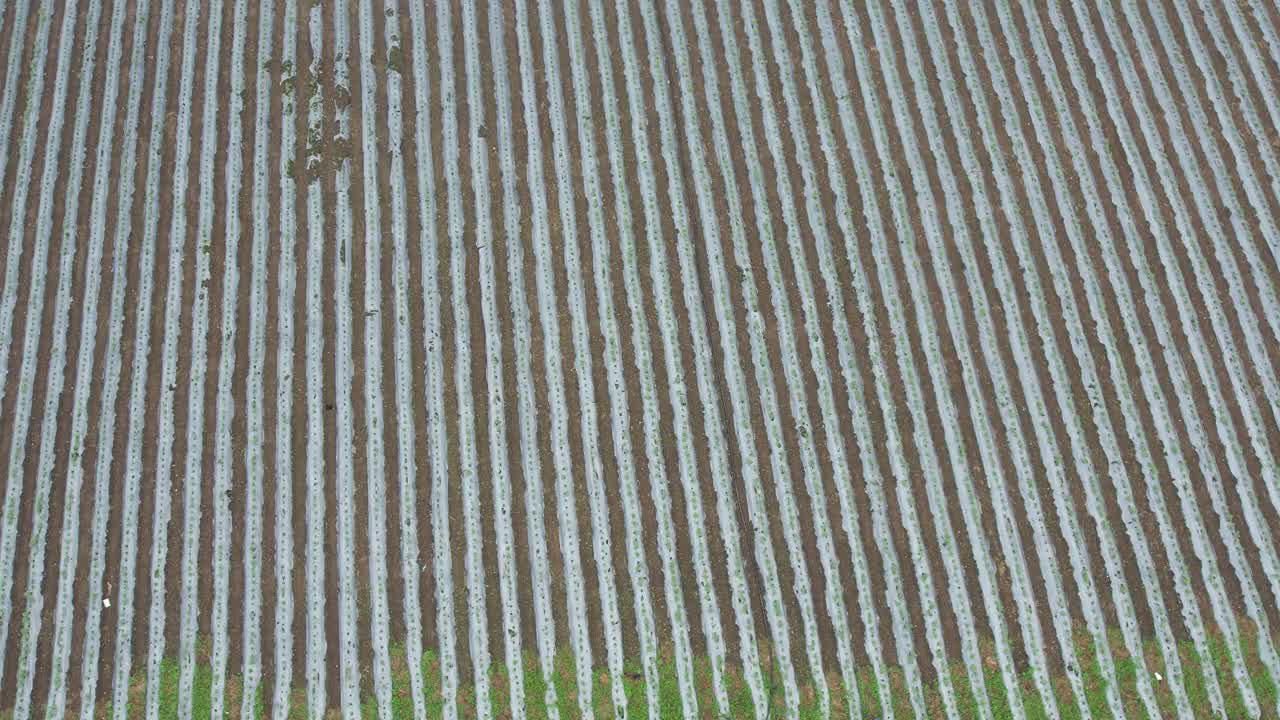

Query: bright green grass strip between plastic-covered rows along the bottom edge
[{"left": 60, "top": 620, "right": 1280, "bottom": 720}]
